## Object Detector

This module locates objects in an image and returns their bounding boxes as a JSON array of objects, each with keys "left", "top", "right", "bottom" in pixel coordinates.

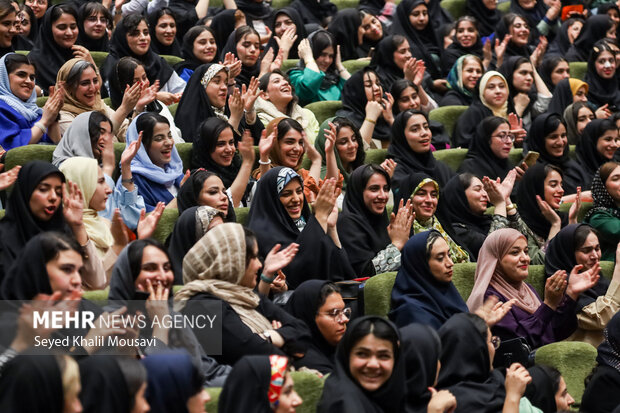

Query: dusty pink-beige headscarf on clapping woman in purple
[{"left": 467, "top": 228, "right": 541, "bottom": 314}]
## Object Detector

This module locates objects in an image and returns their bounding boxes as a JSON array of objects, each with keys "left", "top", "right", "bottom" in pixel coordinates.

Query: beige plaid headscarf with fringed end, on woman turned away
[{"left": 174, "top": 223, "right": 272, "bottom": 338}]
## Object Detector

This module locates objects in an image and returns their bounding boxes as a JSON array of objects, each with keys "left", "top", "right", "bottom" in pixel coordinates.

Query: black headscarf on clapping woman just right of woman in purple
[{"left": 545, "top": 224, "right": 609, "bottom": 309}]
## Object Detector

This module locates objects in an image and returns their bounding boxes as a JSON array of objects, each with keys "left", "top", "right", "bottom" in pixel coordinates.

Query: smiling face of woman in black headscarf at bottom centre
[{"left": 349, "top": 334, "right": 394, "bottom": 392}]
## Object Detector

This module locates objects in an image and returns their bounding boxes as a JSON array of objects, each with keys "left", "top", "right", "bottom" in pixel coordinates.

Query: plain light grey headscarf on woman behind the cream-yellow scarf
[{"left": 52, "top": 112, "right": 95, "bottom": 167}]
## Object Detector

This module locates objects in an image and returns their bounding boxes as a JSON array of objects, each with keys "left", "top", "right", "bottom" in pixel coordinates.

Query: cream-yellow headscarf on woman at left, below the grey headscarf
[{"left": 60, "top": 156, "right": 114, "bottom": 254}]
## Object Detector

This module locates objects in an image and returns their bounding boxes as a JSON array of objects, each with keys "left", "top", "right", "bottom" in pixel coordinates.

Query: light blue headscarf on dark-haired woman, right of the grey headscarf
[{"left": 125, "top": 113, "right": 183, "bottom": 186}]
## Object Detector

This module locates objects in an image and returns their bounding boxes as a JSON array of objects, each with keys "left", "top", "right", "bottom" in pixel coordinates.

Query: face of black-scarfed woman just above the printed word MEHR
[{"left": 45, "top": 246, "right": 84, "bottom": 299}]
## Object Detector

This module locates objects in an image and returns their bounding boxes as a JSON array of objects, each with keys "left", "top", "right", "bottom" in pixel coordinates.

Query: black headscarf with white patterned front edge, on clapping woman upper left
[{"left": 174, "top": 63, "right": 228, "bottom": 142}]
